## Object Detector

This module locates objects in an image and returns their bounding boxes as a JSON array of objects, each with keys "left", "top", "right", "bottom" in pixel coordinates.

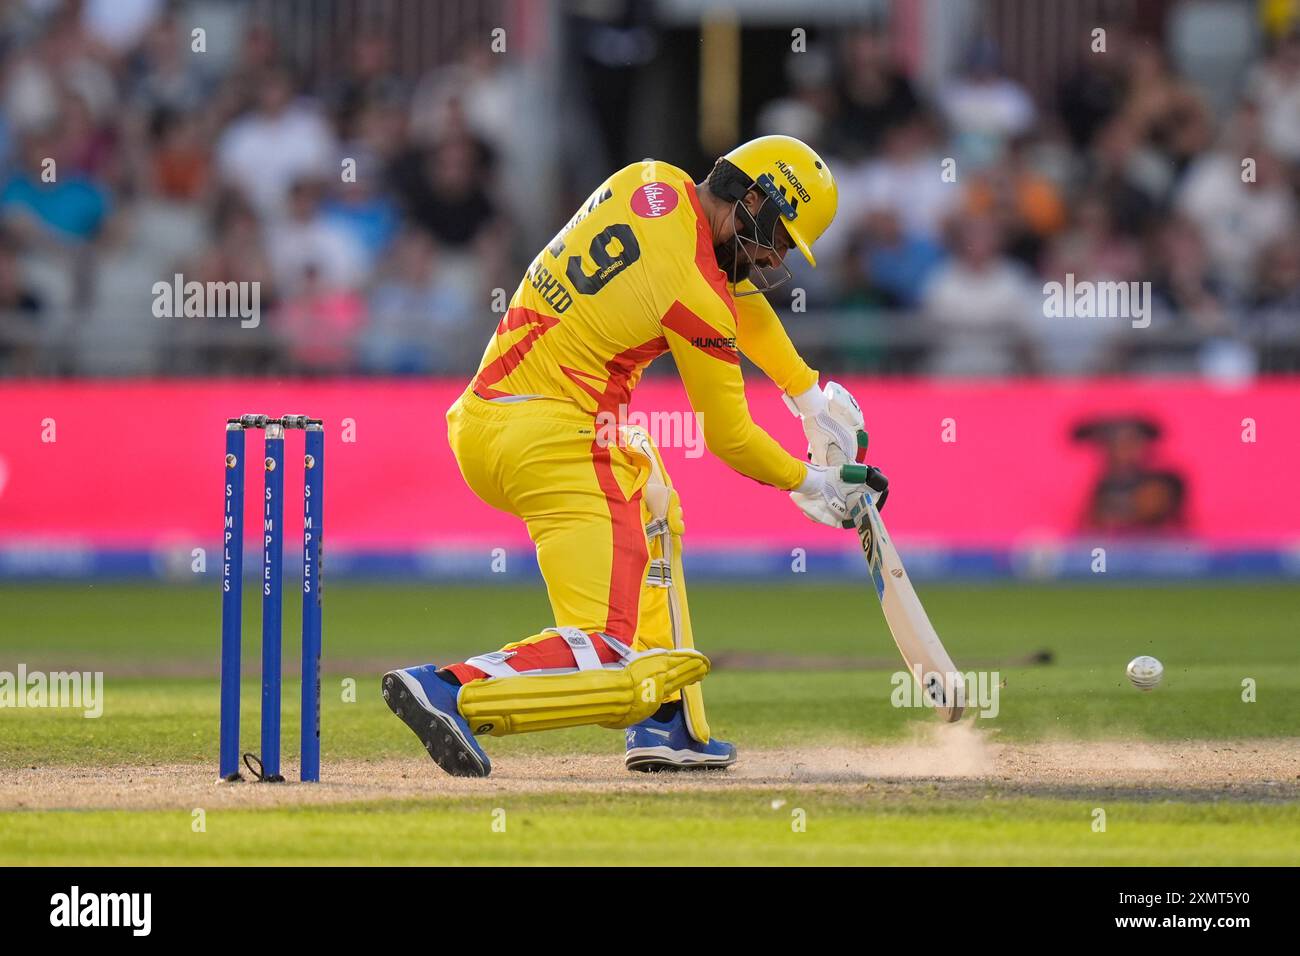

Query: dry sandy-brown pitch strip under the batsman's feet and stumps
[{"left": 0, "top": 723, "right": 1300, "bottom": 810}]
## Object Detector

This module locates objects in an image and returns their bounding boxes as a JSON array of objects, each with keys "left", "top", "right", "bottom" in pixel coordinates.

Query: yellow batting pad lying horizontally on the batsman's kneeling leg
[{"left": 459, "top": 649, "right": 709, "bottom": 737}]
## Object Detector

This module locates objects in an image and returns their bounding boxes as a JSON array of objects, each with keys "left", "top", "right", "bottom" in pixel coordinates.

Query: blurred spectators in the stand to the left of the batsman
[{"left": 0, "top": 0, "right": 517, "bottom": 373}]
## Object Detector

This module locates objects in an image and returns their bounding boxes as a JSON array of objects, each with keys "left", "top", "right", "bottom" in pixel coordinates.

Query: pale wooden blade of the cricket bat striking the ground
[{"left": 850, "top": 496, "right": 966, "bottom": 722}]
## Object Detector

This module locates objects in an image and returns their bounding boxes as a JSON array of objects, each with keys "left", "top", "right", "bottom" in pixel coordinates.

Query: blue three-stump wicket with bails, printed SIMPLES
[{"left": 221, "top": 415, "right": 325, "bottom": 783}]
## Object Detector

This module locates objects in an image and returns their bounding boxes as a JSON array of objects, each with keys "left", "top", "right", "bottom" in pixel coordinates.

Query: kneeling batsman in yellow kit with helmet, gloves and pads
[{"left": 382, "top": 135, "right": 883, "bottom": 777}]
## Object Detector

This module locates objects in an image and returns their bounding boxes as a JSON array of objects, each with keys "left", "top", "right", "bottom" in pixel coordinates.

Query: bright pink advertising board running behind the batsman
[{"left": 0, "top": 378, "right": 1300, "bottom": 550}]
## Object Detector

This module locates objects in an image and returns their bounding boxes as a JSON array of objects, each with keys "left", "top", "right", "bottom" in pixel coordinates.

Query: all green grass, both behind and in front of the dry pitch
[{"left": 0, "top": 583, "right": 1300, "bottom": 865}]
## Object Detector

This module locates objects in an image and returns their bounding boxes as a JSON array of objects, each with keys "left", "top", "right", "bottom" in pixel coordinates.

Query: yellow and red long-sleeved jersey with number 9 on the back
[{"left": 473, "top": 160, "right": 818, "bottom": 489}]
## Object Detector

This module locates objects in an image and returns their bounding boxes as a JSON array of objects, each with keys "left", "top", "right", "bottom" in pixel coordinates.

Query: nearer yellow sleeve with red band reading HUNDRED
[{"left": 663, "top": 291, "right": 807, "bottom": 490}]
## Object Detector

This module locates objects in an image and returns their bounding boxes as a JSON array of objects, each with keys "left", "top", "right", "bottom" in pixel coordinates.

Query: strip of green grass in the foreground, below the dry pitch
[{"left": 0, "top": 787, "right": 1300, "bottom": 866}]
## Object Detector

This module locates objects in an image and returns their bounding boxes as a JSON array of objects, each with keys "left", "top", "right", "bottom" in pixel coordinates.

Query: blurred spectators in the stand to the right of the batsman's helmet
[{"left": 759, "top": 18, "right": 1300, "bottom": 377}]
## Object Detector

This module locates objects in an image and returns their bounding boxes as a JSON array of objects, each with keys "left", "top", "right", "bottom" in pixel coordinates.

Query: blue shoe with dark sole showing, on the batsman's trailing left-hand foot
[{"left": 384, "top": 663, "right": 491, "bottom": 777}]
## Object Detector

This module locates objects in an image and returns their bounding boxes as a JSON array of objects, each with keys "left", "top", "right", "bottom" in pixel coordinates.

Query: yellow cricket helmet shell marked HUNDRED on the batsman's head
[{"left": 723, "top": 135, "right": 840, "bottom": 265}]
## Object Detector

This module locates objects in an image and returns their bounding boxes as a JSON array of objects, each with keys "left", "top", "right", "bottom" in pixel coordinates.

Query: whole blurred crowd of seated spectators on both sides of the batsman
[{"left": 0, "top": 0, "right": 1300, "bottom": 375}]
